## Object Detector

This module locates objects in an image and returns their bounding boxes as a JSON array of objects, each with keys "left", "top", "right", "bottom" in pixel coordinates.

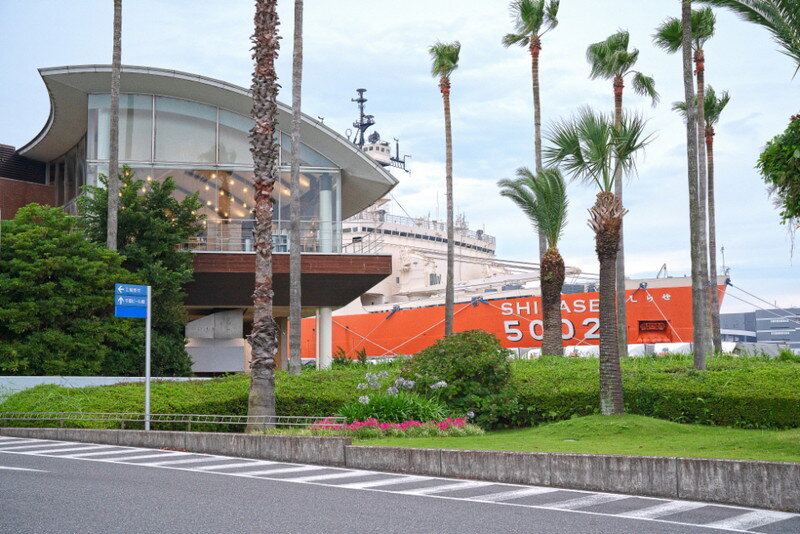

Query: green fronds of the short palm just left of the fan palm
[{"left": 497, "top": 167, "right": 569, "bottom": 247}]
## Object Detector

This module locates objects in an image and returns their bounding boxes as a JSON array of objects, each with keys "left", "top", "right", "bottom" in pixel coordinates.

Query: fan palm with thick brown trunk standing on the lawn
[{"left": 545, "top": 108, "right": 650, "bottom": 415}]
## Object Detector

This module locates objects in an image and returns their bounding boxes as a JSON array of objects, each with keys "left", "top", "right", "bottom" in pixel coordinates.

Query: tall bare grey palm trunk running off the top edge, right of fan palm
[{"left": 681, "top": 0, "right": 709, "bottom": 369}]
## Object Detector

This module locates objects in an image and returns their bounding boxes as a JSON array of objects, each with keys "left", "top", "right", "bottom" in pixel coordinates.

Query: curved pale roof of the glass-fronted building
[{"left": 19, "top": 65, "right": 397, "bottom": 218}]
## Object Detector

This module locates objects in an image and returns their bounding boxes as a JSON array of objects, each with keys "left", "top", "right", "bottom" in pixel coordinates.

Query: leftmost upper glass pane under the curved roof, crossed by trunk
[{"left": 87, "top": 94, "right": 153, "bottom": 161}]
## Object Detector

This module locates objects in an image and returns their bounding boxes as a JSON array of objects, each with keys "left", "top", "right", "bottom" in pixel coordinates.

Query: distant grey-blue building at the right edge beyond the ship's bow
[{"left": 720, "top": 308, "right": 800, "bottom": 351}]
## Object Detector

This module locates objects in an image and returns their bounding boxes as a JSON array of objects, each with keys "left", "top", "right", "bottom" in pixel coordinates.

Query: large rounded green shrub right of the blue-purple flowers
[{"left": 401, "top": 330, "right": 511, "bottom": 415}]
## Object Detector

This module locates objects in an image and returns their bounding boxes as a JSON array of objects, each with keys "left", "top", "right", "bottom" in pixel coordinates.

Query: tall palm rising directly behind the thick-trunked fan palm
[{"left": 586, "top": 31, "right": 658, "bottom": 357}]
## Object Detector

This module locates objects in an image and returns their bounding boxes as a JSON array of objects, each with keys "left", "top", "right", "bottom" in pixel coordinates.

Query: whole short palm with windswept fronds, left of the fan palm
[{"left": 497, "top": 167, "right": 568, "bottom": 356}]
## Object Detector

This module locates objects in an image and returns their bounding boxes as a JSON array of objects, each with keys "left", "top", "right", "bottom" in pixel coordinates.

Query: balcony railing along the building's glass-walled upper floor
[{"left": 184, "top": 219, "right": 342, "bottom": 254}]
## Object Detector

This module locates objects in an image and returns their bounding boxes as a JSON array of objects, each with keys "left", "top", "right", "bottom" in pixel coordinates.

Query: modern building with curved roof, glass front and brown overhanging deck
[{"left": 0, "top": 65, "right": 397, "bottom": 373}]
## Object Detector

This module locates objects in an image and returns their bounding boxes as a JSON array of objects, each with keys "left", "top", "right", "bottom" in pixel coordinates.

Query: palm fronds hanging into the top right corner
[{"left": 700, "top": 0, "right": 800, "bottom": 74}]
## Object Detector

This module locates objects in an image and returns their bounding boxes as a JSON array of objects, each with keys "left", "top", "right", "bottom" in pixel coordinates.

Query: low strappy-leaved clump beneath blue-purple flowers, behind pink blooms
[{"left": 339, "top": 391, "right": 447, "bottom": 423}]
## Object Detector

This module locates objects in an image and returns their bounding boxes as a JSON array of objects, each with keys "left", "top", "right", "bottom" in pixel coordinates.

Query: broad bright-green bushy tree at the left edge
[{"left": 0, "top": 204, "right": 144, "bottom": 376}]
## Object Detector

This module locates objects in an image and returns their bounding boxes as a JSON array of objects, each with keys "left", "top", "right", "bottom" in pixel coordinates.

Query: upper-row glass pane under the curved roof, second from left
[{"left": 155, "top": 97, "right": 217, "bottom": 163}]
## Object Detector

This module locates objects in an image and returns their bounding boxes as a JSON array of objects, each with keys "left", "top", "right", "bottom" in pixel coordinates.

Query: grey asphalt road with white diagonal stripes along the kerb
[{"left": 0, "top": 437, "right": 800, "bottom": 534}]
